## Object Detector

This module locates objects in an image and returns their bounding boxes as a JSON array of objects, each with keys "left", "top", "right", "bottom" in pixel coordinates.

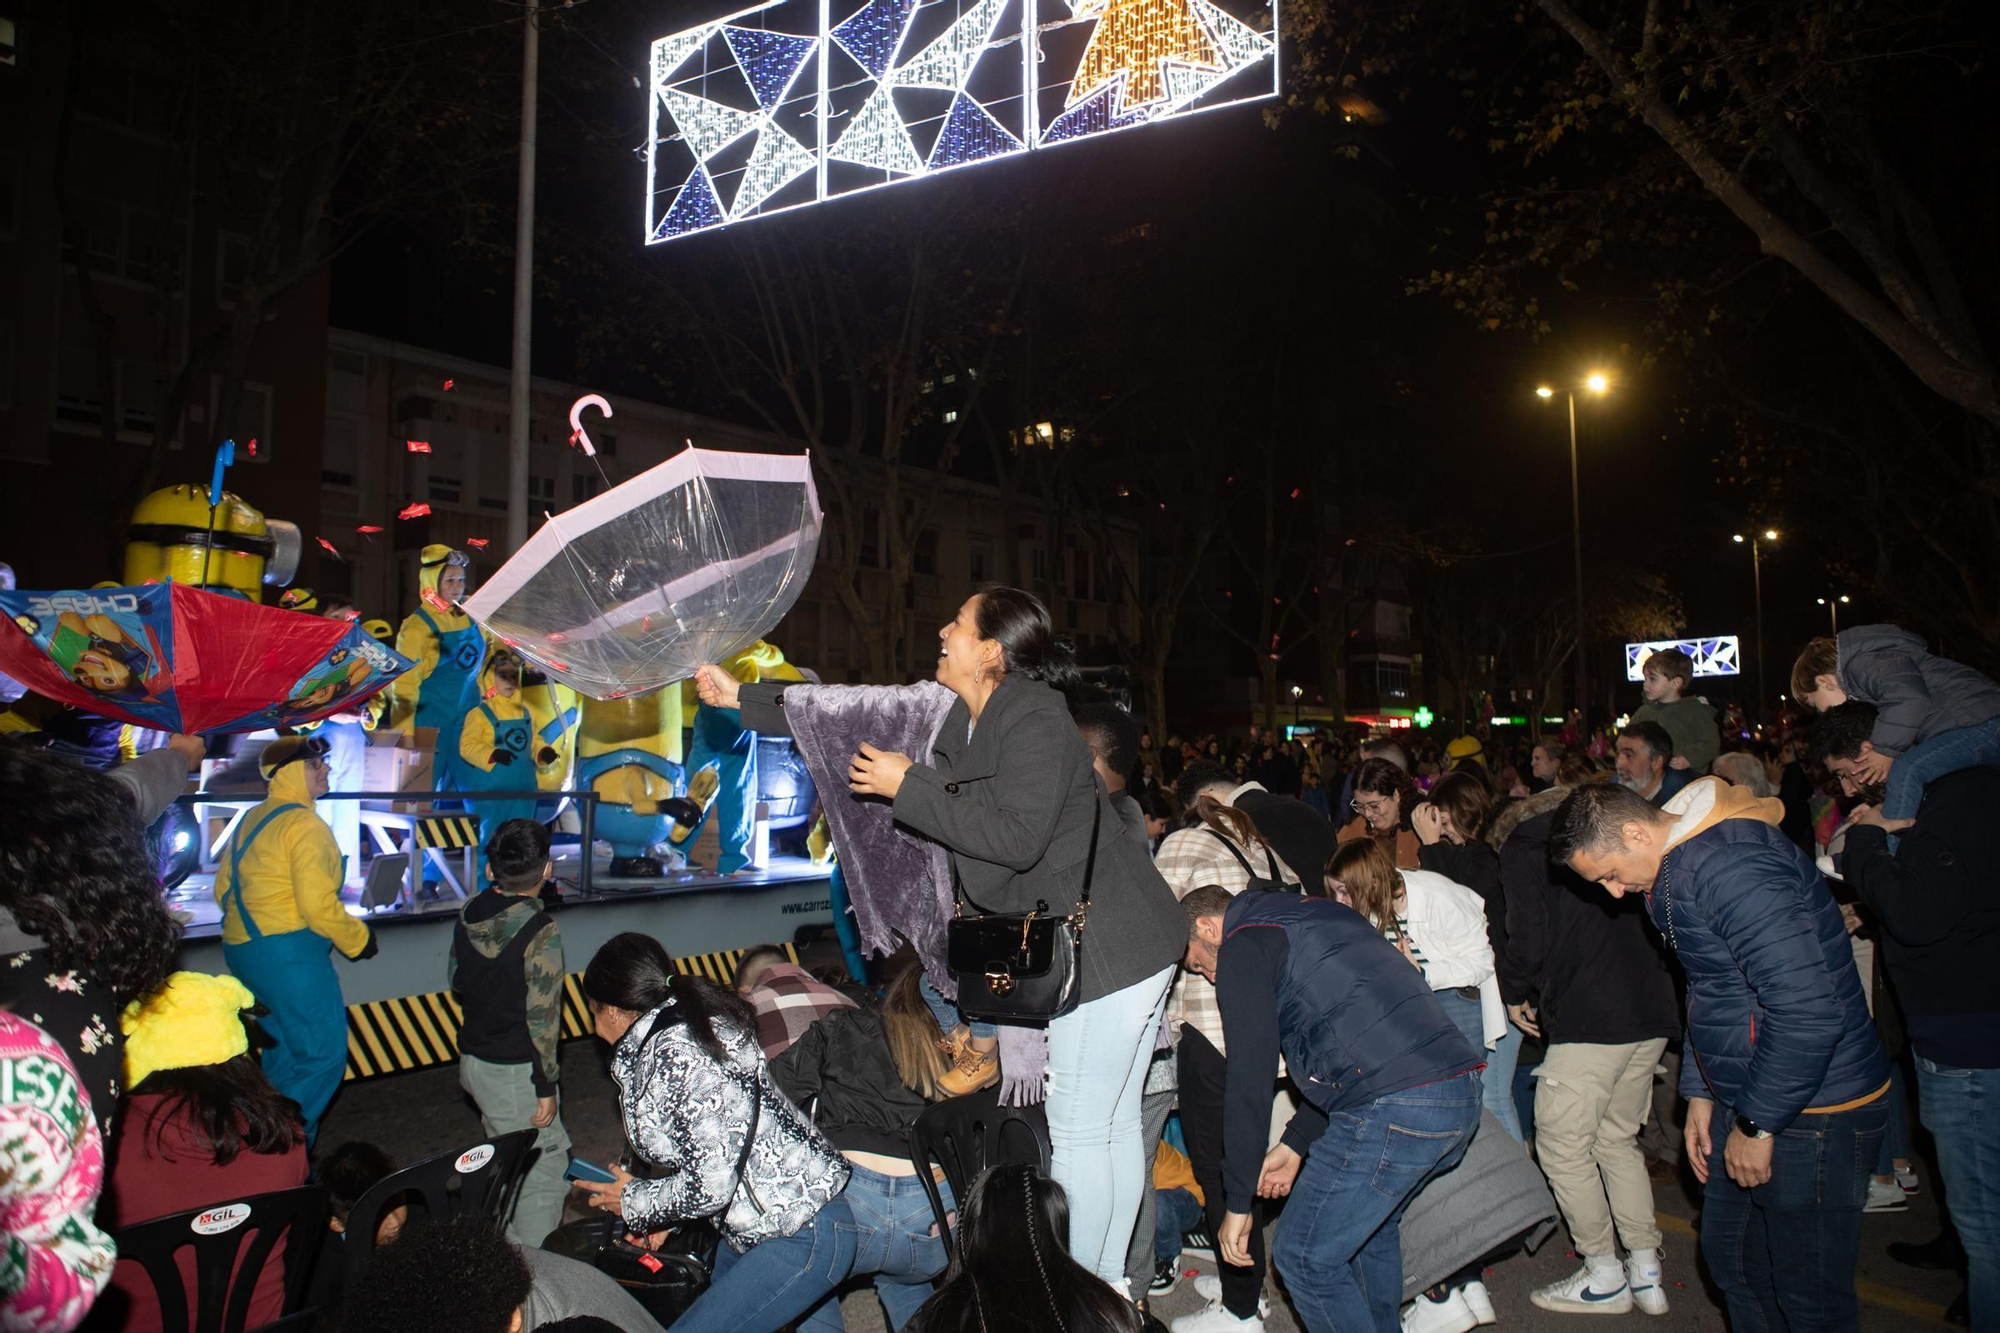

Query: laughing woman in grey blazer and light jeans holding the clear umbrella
[{"left": 696, "top": 588, "right": 1188, "bottom": 1287}]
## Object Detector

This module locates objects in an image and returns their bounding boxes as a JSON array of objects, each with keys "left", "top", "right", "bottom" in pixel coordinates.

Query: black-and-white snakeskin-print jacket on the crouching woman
[{"left": 612, "top": 1001, "right": 848, "bottom": 1253}]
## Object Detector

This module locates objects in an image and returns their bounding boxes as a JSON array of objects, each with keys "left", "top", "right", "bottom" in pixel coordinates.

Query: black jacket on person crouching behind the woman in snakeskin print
[{"left": 770, "top": 1009, "right": 928, "bottom": 1157}]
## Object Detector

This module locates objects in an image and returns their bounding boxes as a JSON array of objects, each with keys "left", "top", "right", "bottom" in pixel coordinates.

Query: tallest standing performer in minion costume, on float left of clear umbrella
[{"left": 388, "top": 544, "right": 486, "bottom": 791}]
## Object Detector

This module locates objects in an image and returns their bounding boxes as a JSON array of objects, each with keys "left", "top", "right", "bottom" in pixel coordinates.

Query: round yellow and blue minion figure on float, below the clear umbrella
[{"left": 576, "top": 689, "right": 702, "bottom": 879}]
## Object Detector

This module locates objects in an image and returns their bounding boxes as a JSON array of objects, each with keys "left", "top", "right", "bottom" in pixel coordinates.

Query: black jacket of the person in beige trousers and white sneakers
[{"left": 1490, "top": 787, "right": 1680, "bottom": 1045}]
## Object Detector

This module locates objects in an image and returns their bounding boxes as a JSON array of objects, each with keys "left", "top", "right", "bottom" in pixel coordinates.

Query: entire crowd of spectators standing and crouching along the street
[{"left": 0, "top": 562, "right": 2000, "bottom": 1333}]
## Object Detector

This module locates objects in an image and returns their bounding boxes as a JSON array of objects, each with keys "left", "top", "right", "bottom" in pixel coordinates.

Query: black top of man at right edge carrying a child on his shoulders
[{"left": 1842, "top": 769, "right": 2000, "bottom": 1069}]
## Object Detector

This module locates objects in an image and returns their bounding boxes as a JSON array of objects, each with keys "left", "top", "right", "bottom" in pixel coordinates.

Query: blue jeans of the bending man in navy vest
[{"left": 1270, "top": 1071, "right": 1480, "bottom": 1333}]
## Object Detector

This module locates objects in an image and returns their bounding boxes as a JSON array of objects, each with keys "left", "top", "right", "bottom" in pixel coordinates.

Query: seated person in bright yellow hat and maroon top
[{"left": 86, "top": 973, "right": 306, "bottom": 1333}]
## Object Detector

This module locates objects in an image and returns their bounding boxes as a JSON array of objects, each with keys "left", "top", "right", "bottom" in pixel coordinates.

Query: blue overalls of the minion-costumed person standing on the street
[{"left": 222, "top": 805, "right": 348, "bottom": 1145}]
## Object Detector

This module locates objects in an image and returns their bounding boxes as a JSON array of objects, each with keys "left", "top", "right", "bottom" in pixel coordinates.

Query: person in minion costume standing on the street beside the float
[{"left": 216, "top": 737, "right": 376, "bottom": 1143}]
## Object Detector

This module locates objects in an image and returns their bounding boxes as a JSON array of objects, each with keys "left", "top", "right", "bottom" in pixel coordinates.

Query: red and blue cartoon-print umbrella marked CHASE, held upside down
[{"left": 0, "top": 582, "right": 414, "bottom": 733}]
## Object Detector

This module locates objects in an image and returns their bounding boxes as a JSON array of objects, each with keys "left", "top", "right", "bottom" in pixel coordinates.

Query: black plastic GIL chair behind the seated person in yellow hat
[{"left": 112, "top": 1185, "right": 326, "bottom": 1333}]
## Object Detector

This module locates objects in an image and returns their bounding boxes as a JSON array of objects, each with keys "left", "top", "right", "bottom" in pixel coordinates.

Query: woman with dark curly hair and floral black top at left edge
[{"left": 0, "top": 743, "right": 180, "bottom": 1135}]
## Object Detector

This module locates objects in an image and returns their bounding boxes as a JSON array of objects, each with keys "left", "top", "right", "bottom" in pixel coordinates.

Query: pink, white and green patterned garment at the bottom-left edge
[{"left": 0, "top": 1011, "right": 116, "bottom": 1333}]
